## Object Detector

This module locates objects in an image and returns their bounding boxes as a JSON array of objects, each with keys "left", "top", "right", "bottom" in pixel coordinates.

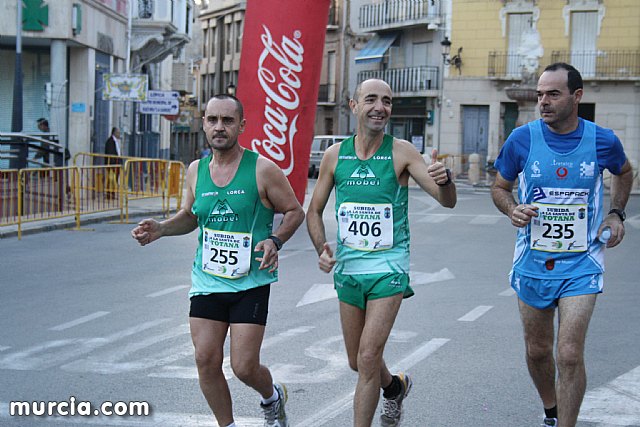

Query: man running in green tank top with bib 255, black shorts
[{"left": 131, "top": 95, "right": 304, "bottom": 427}]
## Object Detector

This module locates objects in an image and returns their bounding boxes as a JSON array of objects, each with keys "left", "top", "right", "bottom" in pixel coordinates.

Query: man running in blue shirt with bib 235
[{"left": 491, "top": 63, "right": 633, "bottom": 427}]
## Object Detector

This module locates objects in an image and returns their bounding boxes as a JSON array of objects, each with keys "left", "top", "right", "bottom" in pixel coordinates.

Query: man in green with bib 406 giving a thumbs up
[{"left": 307, "top": 79, "right": 456, "bottom": 427}]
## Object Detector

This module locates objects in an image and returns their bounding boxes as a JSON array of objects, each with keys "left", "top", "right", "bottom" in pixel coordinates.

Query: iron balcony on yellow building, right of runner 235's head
[{"left": 551, "top": 50, "right": 640, "bottom": 80}]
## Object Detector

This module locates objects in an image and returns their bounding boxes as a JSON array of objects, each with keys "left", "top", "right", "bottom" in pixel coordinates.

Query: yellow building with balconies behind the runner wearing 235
[{"left": 441, "top": 0, "right": 640, "bottom": 187}]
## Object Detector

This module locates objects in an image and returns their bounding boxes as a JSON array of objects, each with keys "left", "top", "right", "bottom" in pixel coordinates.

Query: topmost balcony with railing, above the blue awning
[{"left": 359, "top": 0, "right": 443, "bottom": 31}]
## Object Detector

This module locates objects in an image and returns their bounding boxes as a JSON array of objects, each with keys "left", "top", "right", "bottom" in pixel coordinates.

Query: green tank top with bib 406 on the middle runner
[{"left": 334, "top": 135, "right": 409, "bottom": 274}]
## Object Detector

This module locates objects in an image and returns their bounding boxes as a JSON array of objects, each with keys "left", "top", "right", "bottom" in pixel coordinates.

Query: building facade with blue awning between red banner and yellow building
[{"left": 349, "top": 0, "right": 451, "bottom": 153}]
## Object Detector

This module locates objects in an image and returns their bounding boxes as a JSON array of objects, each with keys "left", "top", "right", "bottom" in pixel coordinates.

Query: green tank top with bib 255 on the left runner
[{"left": 189, "top": 150, "right": 278, "bottom": 297}]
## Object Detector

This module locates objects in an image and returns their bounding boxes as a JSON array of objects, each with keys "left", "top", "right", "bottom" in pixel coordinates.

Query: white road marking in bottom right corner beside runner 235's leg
[{"left": 578, "top": 366, "right": 640, "bottom": 426}]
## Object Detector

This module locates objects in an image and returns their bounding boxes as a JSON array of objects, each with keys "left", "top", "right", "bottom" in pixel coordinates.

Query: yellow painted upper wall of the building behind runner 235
[{"left": 451, "top": 0, "right": 640, "bottom": 77}]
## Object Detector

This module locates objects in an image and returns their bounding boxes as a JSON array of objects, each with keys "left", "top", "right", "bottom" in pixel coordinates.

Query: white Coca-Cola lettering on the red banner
[{"left": 251, "top": 25, "right": 304, "bottom": 176}]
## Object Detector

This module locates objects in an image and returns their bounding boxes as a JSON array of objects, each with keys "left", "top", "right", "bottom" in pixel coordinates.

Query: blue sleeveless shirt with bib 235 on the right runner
[{"left": 513, "top": 120, "right": 604, "bottom": 279}]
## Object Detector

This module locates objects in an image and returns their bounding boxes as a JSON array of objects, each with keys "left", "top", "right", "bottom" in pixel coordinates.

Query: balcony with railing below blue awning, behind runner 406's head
[{"left": 358, "top": 66, "right": 440, "bottom": 97}]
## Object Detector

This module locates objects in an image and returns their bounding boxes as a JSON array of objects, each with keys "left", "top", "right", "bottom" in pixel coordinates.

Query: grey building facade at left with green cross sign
[{"left": 0, "top": 0, "right": 193, "bottom": 164}]
